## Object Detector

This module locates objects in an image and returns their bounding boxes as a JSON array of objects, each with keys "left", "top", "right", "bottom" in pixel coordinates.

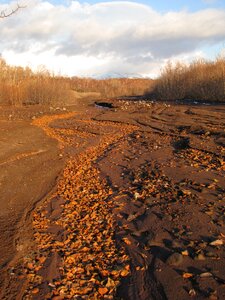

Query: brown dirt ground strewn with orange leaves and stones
[{"left": 0, "top": 100, "right": 225, "bottom": 300}]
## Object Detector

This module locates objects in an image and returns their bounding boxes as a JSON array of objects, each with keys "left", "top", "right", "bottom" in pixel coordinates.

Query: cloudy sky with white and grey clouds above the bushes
[{"left": 0, "top": 0, "right": 225, "bottom": 77}]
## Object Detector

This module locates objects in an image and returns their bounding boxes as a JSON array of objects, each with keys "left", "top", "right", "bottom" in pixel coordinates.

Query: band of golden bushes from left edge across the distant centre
[{"left": 0, "top": 59, "right": 153, "bottom": 106}]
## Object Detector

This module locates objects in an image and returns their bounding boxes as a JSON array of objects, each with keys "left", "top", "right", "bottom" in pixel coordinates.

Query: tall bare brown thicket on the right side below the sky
[{"left": 155, "top": 58, "right": 225, "bottom": 102}]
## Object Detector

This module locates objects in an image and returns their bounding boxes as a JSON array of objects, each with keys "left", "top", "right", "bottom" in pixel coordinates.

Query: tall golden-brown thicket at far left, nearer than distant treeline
[{"left": 0, "top": 59, "right": 69, "bottom": 106}]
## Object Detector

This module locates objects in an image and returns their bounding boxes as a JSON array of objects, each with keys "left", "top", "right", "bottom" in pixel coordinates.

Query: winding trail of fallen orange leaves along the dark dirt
[{"left": 24, "top": 113, "right": 137, "bottom": 299}]
